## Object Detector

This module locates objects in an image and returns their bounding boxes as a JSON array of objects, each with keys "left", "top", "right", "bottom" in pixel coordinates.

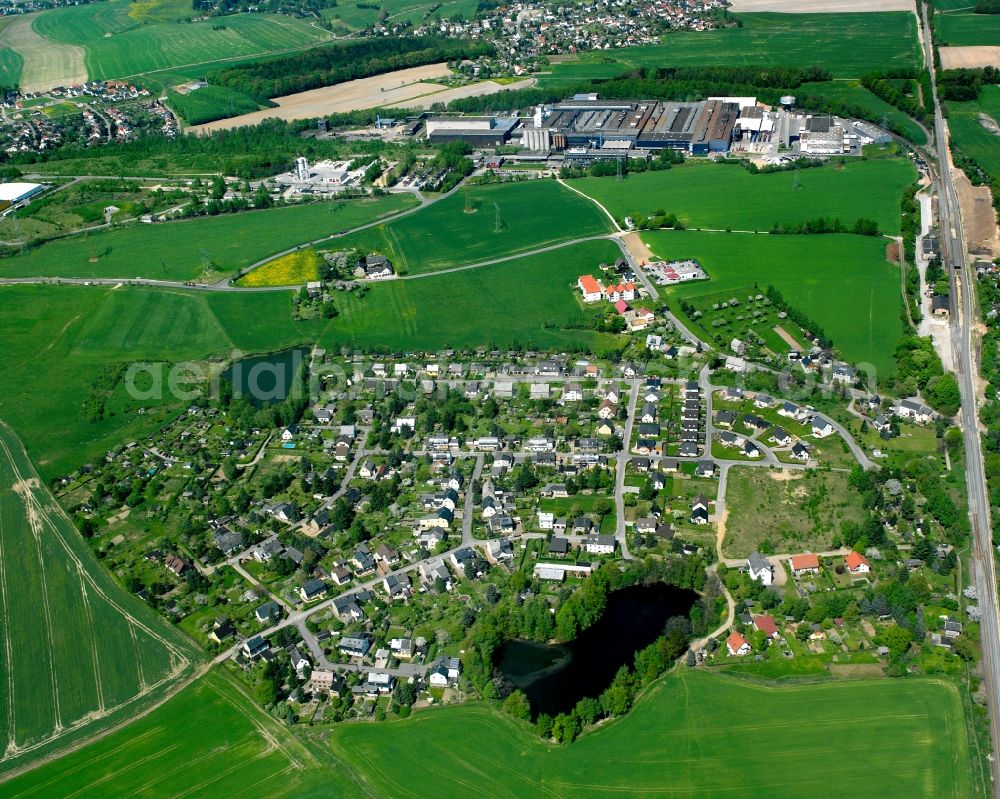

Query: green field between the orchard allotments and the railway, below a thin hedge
[{"left": 642, "top": 231, "right": 903, "bottom": 379}]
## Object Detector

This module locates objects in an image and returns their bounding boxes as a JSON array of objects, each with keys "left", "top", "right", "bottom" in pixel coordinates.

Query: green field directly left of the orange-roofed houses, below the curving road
[{"left": 320, "top": 241, "right": 620, "bottom": 351}]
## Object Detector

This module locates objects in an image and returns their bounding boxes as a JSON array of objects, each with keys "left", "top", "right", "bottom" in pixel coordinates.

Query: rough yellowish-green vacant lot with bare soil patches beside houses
[{"left": 722, "top": 467, "right": 864, "bottom": 558}]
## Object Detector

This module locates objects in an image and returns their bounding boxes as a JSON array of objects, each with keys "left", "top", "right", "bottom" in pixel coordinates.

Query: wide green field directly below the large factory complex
[{"left": 569, "top": 158, "right": 916, "bottom": 234}]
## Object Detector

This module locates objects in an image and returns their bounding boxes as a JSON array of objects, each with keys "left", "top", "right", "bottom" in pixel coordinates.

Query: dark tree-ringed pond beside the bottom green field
[{"left": 497, "top": 583, "right": 698, "bottom": 716}]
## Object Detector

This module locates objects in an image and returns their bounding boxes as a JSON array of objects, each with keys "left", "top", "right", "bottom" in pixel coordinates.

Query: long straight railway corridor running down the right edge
[{"left": 921, "top": 6, "right": 1000, "bottom": 797}]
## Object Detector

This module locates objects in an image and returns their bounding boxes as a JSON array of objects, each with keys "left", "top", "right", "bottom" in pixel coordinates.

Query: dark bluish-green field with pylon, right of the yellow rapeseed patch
[{"left": 327, "top": 180, "right": 611, "bottom": 274}]
